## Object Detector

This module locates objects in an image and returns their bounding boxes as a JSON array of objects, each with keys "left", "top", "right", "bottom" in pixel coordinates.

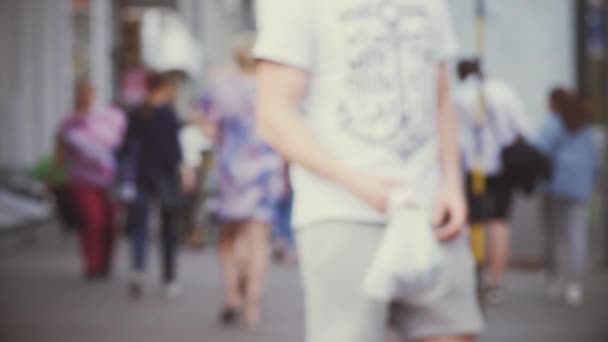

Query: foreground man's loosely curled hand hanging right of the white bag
[{"left": 433, "top": 185, "right": 467, "bottom": 241}]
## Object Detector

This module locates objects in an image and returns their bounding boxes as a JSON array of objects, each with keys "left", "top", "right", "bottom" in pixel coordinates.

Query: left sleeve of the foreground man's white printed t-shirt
[{"left": 254, "top": 0, "right": 313, "bottom": 70}]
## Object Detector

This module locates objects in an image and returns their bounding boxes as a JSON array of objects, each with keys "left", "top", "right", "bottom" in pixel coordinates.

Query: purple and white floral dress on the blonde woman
[{"left": 201, "top": 75, "right": 285, "bottom": 224}]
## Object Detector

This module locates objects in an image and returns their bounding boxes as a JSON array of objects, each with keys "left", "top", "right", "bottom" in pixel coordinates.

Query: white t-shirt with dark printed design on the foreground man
[{"left": 255, "top": 0, "right": 456, "bottom": 226}]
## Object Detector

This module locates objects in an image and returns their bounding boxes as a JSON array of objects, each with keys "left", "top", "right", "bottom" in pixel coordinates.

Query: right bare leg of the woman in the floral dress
[{"left": 242, "top": 222, "right": 270, "bottom": 327}]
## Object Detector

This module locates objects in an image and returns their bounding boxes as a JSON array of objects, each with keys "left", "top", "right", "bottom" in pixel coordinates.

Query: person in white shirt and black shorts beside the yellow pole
[{"left": 455, "top": 60, "right": 531, "bottom": 304}]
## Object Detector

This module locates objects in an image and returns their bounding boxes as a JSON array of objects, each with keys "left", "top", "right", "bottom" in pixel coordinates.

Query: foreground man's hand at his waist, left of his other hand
[{"left": 344, "top": 173, "right": 403, "bottom": 213}]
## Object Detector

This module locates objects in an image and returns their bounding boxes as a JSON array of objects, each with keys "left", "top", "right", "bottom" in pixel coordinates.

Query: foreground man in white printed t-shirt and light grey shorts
[{"left": 255, "top": 0, "right": 482, "bottom": 342}]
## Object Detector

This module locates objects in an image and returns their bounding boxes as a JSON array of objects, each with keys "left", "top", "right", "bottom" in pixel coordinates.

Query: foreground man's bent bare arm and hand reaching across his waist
[{"left": 257, "top": 61, "right": 395, "bottom": 211}]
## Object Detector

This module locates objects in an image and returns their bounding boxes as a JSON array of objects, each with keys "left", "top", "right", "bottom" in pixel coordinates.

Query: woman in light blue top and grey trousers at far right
[{"left": 537, "top": 89, "right": 599, "bottom": 305}]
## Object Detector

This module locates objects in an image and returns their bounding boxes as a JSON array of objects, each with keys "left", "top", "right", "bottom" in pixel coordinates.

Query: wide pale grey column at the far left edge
[{"left": 0, "top": 0, "right": 72, "bottom": 167}]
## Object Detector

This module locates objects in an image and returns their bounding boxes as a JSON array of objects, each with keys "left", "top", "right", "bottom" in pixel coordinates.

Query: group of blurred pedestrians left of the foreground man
[{"left": 37, "top": 37, "right": 295, "bottom": 326}]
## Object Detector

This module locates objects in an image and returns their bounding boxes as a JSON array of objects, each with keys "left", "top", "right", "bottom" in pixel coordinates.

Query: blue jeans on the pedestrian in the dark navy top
[{"left": 127, "top": 191, "right": 178, "bottom": 283}]
